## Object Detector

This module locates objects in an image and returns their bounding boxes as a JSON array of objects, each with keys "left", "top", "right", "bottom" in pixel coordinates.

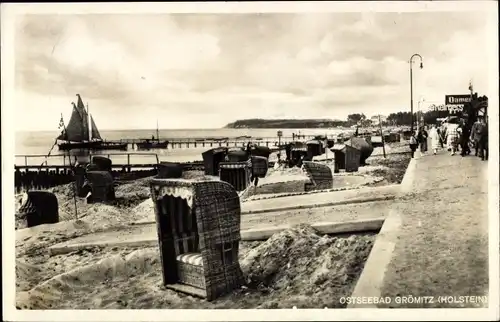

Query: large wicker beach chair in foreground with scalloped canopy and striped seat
[{"left": 151, "top": 178, "right": 243, "bottom": 301}]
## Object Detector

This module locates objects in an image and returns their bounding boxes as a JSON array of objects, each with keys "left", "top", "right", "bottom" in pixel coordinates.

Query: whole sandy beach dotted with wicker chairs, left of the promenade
[{"left": 16, "top": 143, "right": 409, "bottom": 309}]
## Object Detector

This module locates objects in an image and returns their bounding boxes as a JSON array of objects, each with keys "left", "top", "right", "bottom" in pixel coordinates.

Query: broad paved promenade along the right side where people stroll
[{"left": 353, "top": 151, "right": 488, "bottom": 308}]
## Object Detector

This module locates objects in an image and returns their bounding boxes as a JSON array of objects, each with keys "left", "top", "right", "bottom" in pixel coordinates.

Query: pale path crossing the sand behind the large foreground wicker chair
[{"left": 47, "top": 185, "right": 399, "bottom": 253}]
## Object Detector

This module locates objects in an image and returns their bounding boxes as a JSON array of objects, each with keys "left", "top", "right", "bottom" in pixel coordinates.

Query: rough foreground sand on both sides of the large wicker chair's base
[{"left": 16, "top": 225, "right": 374, "bottom": 309}]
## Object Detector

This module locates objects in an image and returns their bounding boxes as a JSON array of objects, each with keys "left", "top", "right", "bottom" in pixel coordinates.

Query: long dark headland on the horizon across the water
[{"left": 224, "top": 119, "right": 352, "bottom": 129}]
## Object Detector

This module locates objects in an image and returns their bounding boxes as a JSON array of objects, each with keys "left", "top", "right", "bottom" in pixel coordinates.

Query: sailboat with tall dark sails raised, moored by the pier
[{"left": 57, "top": 94, "right": 127, "bottom": 151}]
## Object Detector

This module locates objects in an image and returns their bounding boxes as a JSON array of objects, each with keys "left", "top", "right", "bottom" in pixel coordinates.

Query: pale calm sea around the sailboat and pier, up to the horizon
[{"left": 15, "top": 128, "right": 352, "bottom": 165}]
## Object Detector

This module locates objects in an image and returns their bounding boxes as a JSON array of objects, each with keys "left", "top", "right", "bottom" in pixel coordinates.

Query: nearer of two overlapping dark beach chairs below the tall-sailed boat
[{"left": 82, "top": 171, "right": 115, "bottom": 203}]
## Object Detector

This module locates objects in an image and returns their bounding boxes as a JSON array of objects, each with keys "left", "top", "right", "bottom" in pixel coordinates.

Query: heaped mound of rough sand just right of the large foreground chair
[{"left": 241, "top": 225, "right": 373, "bottom": 308}]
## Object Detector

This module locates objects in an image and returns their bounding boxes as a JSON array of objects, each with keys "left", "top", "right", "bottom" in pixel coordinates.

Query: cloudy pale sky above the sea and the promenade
[{"left": 14, "top": 7, "right": 497, "bottom": 131}]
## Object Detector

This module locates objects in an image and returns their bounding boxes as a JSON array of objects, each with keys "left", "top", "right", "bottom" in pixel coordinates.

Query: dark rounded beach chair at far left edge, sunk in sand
[{"left": 18, "top": 190, "right": 59, "bottom": 228}]
